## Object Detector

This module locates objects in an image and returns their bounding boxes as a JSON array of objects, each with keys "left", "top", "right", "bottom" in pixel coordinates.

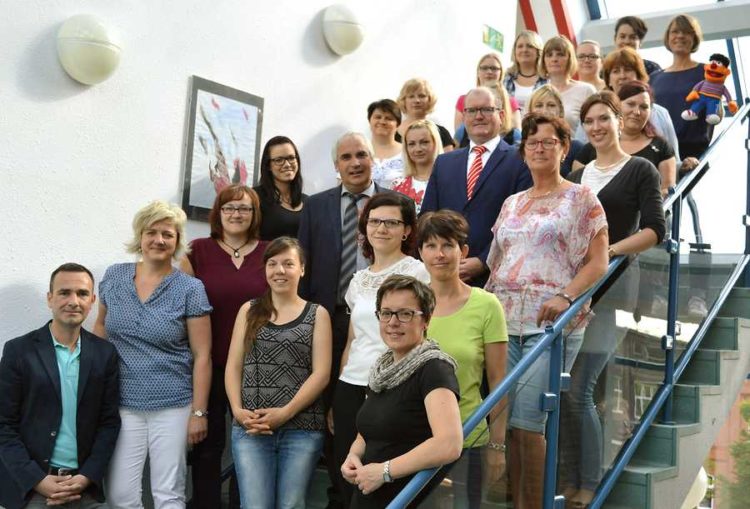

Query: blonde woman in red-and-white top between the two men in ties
[{"left": 391, "top": 120, "right": 443, "bottom": 214}]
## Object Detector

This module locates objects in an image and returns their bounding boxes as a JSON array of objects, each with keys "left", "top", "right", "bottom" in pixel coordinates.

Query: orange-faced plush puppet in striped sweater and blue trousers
[{"left": 682, "top": 53, "right": 737, "bottom": 125}]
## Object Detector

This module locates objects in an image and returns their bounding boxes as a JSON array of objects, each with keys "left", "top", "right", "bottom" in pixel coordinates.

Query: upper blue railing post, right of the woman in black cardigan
[{"left": 661, "top": 196, "right": 682, "bottom": 424}]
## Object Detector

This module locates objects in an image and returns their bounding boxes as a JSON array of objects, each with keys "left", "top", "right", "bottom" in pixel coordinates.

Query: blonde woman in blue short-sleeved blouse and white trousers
[{"left": 94, "top": 201, "right": 212, "bottom": 508}]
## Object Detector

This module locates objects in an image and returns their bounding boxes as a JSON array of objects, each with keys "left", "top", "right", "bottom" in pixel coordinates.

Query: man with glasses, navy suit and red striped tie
[{"left": 421, "top": 87, "right": 531, "bottom": 286}]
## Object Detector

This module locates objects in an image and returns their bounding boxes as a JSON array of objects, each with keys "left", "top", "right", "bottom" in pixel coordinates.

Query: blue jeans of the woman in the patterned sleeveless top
[{"left": 232, "top": 424, "right": 324, "bottom": 509}]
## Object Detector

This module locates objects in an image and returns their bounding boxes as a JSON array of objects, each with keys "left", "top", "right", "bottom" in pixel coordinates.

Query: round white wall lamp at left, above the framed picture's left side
[{"left": 57, "top": 14, "right": 122, "bottom": 85}]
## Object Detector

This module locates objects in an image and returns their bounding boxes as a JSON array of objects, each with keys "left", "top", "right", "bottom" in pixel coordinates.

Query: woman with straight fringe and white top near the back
[{"left": 539, "top": 35, "right": 596, "bottom": 133}]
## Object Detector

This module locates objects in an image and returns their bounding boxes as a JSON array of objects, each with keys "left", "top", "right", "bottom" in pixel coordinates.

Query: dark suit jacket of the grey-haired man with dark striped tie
[{"left": 297, "top": 184, "right": 388, "bottom": 316}]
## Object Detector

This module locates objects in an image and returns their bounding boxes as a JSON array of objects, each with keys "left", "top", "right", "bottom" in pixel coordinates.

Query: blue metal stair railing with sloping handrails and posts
[{"left": 387, "top": 99, "right": 750, "bottom": 509}]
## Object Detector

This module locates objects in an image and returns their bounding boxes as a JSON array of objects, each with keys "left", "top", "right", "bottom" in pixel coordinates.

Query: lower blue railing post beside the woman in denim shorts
[{"left": 539, "top": 325, "right": 565, "bottom": 509}]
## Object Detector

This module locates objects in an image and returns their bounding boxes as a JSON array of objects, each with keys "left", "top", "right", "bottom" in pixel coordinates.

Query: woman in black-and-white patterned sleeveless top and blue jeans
[{"left": 225, "top": 237, "right": 331, "bottom": 509}]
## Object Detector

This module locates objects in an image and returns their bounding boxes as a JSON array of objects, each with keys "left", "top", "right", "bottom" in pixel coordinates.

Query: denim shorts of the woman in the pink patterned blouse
[{"left": 507, "top": 333, "right": 583, "bottom": 433}]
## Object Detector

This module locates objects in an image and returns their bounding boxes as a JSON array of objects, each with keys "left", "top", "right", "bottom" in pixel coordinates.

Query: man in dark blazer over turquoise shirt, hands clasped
[{"left": 0, "top": 263, "right": 120, "bottom": 509}]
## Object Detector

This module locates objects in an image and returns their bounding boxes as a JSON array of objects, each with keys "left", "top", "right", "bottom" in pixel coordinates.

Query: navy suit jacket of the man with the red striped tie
[{"left": 420, "top": 140, "right": 531, "bottom": 286}]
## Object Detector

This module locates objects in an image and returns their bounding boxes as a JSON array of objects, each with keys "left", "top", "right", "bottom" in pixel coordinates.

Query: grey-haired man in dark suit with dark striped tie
[{"left": 297, "top": 132, "right": 385, "bottom": 508}]
